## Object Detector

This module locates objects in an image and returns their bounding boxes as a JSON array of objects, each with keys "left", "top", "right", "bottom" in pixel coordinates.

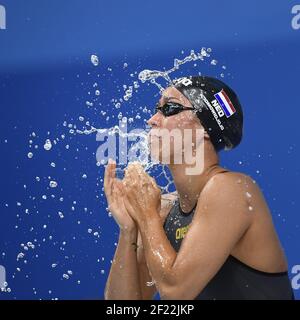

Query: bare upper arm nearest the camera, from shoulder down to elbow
[{"left": 165, "top": 175, "right": 252, "bottom": 299}]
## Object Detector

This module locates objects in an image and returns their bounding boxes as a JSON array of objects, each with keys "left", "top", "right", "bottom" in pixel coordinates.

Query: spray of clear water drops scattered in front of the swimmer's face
[{"left": 2, "top": 48, "right": 230, "bottom": 295}]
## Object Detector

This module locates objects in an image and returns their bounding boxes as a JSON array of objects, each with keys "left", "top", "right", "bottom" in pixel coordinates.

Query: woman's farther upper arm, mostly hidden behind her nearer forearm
[{"left": 137, "top": 192, "right": 176, "bottom": 300}]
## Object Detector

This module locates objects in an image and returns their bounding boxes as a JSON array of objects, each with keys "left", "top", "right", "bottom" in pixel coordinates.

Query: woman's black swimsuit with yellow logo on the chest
[{"left": 164, "top": 199, "right": 294, "bottom": 300}]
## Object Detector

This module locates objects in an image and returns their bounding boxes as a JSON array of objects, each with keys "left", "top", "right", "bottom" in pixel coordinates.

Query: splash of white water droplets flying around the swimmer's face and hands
[{"left": 5, "top": 48, "right": 230, "bottom": 294}]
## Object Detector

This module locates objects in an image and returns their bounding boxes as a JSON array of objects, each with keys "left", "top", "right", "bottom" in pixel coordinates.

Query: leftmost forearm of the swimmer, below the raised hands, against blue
[{"left": 104, "top": 231, "right": 142, "bottom": 300}]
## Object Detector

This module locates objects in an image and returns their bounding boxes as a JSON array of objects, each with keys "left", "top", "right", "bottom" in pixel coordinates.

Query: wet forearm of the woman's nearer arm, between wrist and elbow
[{"left": 140, "top": 214, "right": 177, "bottom": 296}]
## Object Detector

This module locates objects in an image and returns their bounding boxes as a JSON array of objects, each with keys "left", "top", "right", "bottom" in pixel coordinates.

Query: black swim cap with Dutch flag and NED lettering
[{"left": 173, "top": 76, "right": 243, "bottom": 151}]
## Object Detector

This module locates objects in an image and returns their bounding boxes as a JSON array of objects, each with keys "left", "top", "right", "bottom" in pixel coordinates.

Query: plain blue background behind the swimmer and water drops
[{"left": 0, "top": 0, "right": 300, "bottom": 299}]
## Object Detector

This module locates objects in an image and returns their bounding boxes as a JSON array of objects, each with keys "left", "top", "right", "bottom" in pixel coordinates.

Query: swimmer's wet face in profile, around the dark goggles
[{"left": 148, "top": 87, "right": 203, "bottom": 164}]
